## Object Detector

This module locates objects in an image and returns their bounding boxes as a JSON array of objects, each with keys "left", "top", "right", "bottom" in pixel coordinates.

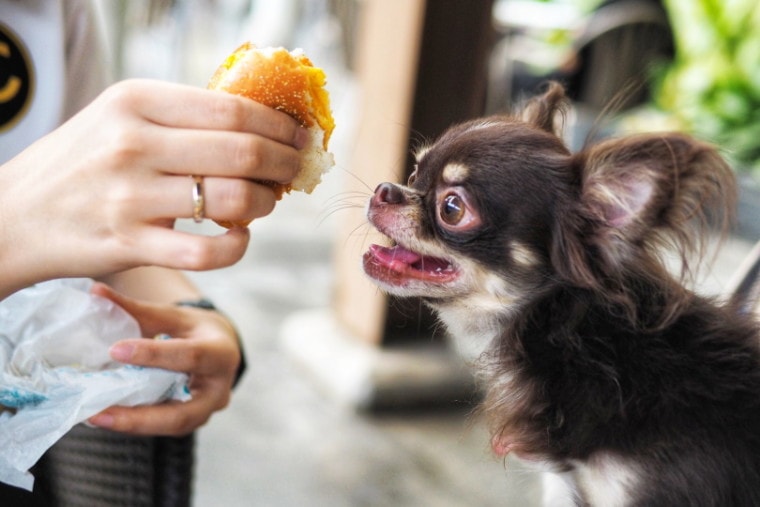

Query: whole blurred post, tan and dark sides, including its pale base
[{"left": 282, "top": 0, "right": 492, "bottom": 408}]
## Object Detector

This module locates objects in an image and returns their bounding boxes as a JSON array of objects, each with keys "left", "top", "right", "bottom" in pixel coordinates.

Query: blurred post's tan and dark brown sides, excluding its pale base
[{"left": 335, "top": 0, "right": 492, "bottom": 345}]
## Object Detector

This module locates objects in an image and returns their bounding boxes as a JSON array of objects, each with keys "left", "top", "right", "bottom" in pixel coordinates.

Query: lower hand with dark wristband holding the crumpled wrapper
[{"left": 89, "top": 284, "right": 242, "bottom": 436}]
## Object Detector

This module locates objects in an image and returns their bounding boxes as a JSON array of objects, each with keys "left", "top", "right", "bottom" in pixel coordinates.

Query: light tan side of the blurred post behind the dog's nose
[{"left": 335, "top": 0, "right": 426, "bottom": 344}]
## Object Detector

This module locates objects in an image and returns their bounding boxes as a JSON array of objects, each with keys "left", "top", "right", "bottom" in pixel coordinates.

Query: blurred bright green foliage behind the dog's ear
[{"left": 657, "top": 0, "right": 760, "bottom": 174}]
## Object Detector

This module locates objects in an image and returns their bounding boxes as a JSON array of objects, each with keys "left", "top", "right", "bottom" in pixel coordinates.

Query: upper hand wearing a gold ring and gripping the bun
[{"left": 0, "top": 80, "right": 308, "bottom": 298}]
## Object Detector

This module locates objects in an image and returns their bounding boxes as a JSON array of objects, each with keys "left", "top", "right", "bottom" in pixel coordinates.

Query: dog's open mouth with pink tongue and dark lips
[{"left": 364, "top": 245, "right": 459, "bottom": 285}]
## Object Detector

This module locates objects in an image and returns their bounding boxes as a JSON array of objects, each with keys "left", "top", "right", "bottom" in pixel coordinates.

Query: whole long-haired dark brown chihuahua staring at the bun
[{"left": 363, "top": 83, "right": 760, "bottom": 507}]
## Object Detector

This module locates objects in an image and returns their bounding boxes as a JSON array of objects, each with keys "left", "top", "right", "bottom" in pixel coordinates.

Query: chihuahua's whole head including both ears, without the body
[{"left": 364, "top": 84, "right": 734, "bottom": 328}]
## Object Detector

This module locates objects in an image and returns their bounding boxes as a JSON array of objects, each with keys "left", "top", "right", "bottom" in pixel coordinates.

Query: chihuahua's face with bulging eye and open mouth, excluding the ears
[{"left": 364, "top": 89, "right": 569, "bottom": 314}]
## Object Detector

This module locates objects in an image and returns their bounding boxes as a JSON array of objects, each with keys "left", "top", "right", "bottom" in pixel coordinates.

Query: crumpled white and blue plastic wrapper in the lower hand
[{"left": 0, "top": 279, "right": 190, "bottom": 490}]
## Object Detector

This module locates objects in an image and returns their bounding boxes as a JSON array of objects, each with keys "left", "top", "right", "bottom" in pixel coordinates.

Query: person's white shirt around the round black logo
[{"left": 0, "top": 0, "right": 110, "bottom": 163}]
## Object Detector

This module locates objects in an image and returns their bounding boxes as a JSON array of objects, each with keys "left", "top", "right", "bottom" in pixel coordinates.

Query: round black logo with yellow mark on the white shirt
[{"left": 0, "top": 23, "right": 33, "bottom": 132}]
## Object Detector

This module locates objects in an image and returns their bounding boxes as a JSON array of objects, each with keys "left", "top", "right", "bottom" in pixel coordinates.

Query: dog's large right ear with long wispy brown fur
[{"left": 560, "top": 133, "right": 736, "bottom": 282}]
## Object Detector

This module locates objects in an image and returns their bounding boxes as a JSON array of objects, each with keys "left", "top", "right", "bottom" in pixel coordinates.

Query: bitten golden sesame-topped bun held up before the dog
[{"left": 208, "top": 43, "right": 335, "bottom": 227}]
